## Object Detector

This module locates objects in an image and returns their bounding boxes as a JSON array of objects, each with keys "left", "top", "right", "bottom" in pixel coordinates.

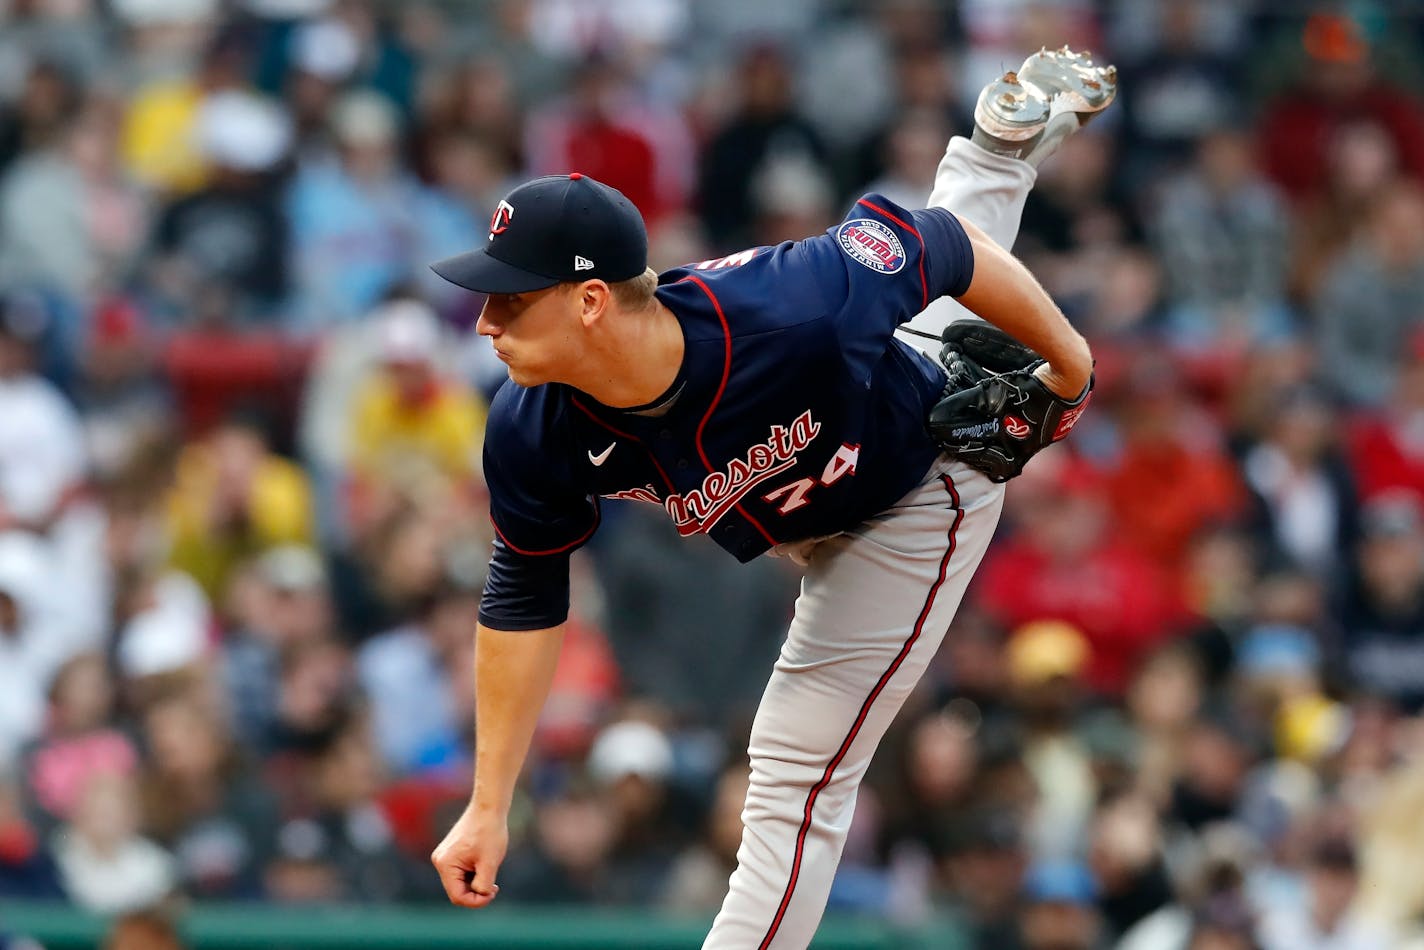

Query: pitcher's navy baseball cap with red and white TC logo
[{"left": 430, "top": 172, "right": 648, "bottom": 293}]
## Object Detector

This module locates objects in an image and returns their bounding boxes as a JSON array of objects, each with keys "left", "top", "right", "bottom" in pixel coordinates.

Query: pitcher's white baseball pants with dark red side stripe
[{"left": 703, "top": 137, "right": 1037, "bottom": 950}]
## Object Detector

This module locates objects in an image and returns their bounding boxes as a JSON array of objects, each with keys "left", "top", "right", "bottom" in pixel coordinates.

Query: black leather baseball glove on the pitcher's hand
[{"left": 928, "top": 320, "right": 1092, "bottom": 481}]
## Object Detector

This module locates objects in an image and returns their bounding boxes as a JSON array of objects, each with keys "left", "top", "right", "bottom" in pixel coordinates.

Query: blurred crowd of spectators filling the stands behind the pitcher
[{"left": 0, "top": 0, "right": 1424, "bottom": 950}]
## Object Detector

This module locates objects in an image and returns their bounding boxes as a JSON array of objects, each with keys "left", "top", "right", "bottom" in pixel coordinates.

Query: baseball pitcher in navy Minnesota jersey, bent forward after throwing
[{"left": 431, "top": 48, "right": 1115, "bottom": 950}]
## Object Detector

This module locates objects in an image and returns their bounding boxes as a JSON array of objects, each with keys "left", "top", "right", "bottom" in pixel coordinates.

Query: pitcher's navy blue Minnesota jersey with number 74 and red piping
[{"left": 480, "top": 195, "right": 974, "bottom": 630}]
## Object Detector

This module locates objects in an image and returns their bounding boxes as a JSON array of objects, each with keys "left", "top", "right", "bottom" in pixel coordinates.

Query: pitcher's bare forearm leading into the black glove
[{"left": 958, "top": 219, "right": 1092, "bottom": 399}]
